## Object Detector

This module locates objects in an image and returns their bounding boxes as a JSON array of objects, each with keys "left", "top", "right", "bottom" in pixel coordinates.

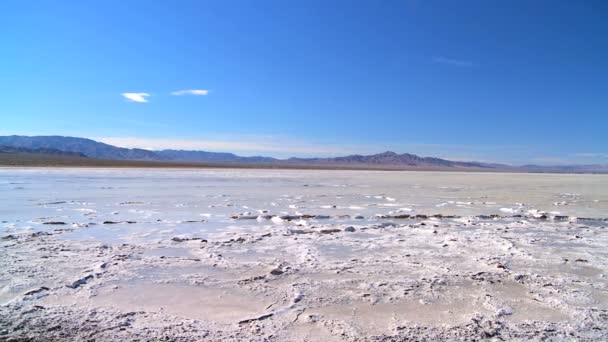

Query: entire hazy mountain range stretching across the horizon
[{"left": 0, "top": 135, "right": 608, "bottom": 172}]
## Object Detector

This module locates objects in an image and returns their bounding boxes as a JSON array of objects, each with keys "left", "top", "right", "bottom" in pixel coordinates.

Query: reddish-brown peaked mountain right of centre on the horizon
[{"left": 287, "top": 151, "right": 498, "bottom": 168}]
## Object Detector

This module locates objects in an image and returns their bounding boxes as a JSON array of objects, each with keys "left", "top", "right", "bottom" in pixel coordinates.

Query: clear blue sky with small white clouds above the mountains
[{"left": 0, "top": 0, "right": 608, "bottom": 164}]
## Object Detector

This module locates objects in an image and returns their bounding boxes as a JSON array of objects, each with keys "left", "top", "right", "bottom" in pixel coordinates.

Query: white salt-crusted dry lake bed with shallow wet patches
[{"left": 0, "top": 168, "right": 608, "bottom": 341}]
